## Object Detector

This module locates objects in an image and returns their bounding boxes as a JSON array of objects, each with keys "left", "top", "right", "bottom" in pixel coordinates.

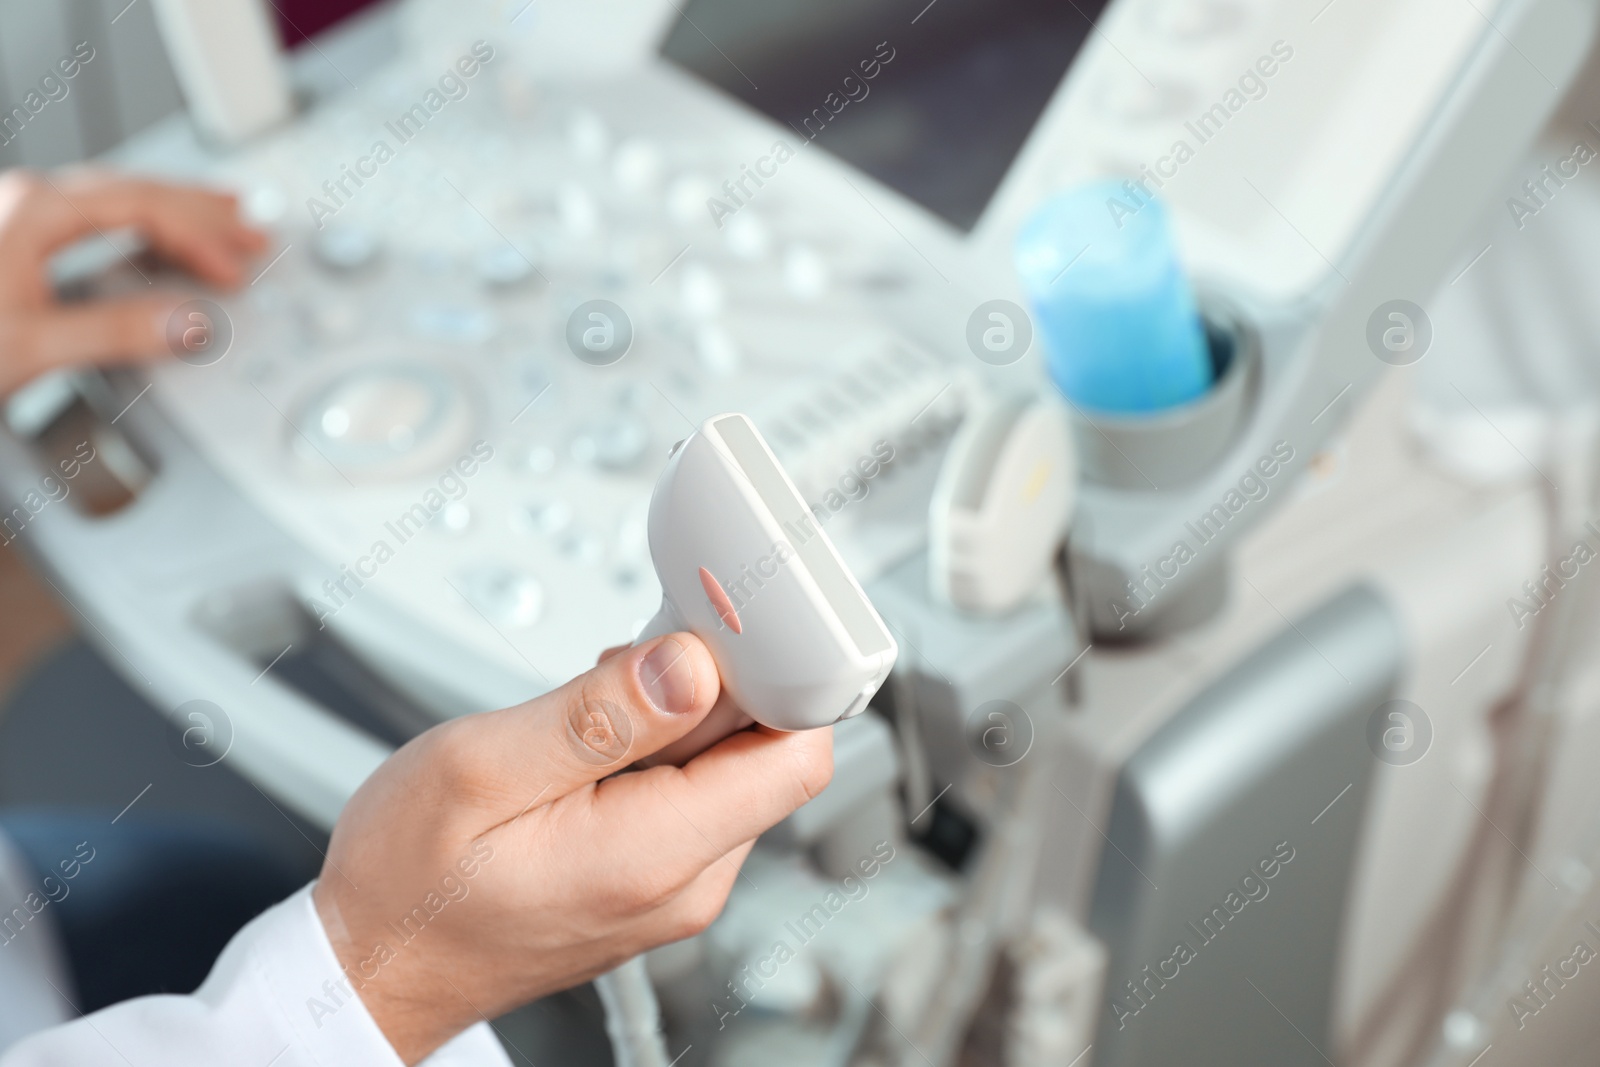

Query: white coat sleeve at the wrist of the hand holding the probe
[{"left": 0, "top": 886, "right": 510, "bottom": 1067}]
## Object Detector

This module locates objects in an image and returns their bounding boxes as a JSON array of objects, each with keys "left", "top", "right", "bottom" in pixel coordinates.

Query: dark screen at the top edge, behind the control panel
[{"left": 661, "top": 0, "right": 1106, "bottom": 230}]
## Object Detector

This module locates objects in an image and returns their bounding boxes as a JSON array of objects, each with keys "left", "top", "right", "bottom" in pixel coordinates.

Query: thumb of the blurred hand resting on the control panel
[{"left": 3, "top": 296, "right": 179, "bottom": 387}]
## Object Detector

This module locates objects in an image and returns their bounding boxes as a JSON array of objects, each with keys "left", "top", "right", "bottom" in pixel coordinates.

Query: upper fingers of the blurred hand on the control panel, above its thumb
[{"left": 0, "top": 171, "right": 266, "bottom": 285}]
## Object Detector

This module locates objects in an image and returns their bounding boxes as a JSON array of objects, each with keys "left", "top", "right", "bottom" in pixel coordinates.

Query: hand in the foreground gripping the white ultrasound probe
[{"left": 314, "top": 633, "right": 834, "bottom": 1064}]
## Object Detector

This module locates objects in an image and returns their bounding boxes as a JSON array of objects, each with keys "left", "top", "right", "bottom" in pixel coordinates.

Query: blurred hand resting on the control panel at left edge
[{"left": 0, "top": 170, "right": 267, "bottom": 395}]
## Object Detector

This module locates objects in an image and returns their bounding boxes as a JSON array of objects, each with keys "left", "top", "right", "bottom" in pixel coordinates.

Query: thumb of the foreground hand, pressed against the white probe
[{"left": 434, "top": 633, "right": 722, "bottom": 819}]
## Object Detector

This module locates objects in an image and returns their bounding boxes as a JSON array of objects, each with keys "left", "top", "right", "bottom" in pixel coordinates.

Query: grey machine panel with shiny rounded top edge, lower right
[{"left": 1090, "top": 585, "right": 1405, "bottom": 1067}]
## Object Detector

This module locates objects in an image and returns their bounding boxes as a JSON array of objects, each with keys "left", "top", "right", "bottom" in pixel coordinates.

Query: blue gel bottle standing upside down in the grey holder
[{"left": 1016, "top": 182, "right": 1213, "bottom": 414}]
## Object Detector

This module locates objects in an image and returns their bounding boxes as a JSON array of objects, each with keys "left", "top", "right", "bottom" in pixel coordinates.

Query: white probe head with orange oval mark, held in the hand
[{"left": 638, "top": 414, "right": 899, "bottom": 729}]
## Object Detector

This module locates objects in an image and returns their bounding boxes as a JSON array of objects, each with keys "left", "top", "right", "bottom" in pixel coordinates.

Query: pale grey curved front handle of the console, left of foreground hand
[{"left": 0, "top": 379, "right": 390, "bottom": 829}]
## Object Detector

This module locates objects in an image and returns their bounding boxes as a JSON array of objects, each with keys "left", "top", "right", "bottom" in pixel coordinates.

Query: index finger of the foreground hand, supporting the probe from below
[{"left": 595, "top": 726, "right": 834, "bottom": 869}]
